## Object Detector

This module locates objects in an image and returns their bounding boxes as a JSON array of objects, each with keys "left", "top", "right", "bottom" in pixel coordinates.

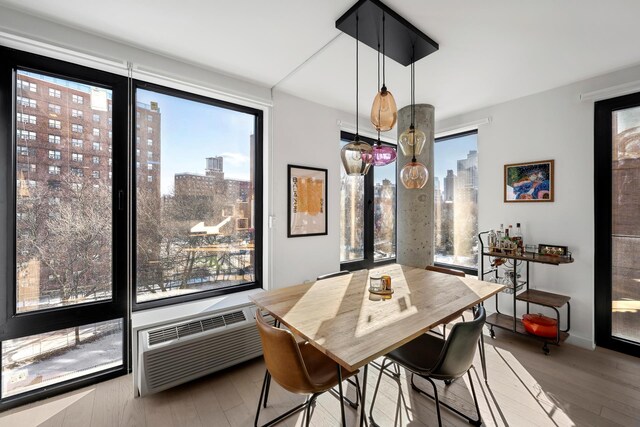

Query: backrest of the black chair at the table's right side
[{"left": 431, "top": 306, "right": 487, "bottom": 379}]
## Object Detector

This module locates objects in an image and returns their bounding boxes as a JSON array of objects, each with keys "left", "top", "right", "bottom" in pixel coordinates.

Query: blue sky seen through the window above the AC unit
[{"left": 136, "top": 89, "right": 255, "bottom": 198}]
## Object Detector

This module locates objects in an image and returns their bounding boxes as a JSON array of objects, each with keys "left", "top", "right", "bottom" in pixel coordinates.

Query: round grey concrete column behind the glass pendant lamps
[{"left": 396, "top": 104, "right": 434, "bottom": 268}]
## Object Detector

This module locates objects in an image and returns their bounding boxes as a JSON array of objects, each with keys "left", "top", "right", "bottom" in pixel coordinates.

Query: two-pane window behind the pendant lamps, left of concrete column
[{"left": 340, "top": 132, "right": 396, "bottom": 270}]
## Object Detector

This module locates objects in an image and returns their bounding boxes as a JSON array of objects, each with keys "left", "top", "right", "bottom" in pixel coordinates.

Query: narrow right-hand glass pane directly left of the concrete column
[{"left": 369, "top": 162, "right": 396, "bottom": 261}]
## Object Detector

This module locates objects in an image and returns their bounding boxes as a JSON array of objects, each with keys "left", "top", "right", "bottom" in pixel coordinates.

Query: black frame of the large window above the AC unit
[{"left": 128, "top": 79, "right": 264, "bottom": 312}]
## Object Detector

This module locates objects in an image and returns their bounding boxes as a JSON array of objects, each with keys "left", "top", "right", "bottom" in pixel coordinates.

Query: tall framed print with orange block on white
[{"left": 287, "top": 165, "right": 329, "bottom": 237}]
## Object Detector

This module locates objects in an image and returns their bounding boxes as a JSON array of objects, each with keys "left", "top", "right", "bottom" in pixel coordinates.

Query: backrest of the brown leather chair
[{"left": 256, "top": 310, "right": 314, "bottom": 393}]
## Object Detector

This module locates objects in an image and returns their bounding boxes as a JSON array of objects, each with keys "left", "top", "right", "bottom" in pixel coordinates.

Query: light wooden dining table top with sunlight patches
[{"left": 249, "top": 264, "right": 504, "bottom": 370}]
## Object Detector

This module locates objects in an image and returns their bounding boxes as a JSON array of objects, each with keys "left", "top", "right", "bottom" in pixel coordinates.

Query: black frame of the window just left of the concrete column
[{"left": 340, "top": 131, "right": 398, "bottom": 271}]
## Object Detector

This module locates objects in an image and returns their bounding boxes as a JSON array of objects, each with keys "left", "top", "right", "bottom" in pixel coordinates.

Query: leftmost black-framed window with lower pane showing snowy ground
[{"left": 0, "top": 48, "right": 129, "bottom": 411}]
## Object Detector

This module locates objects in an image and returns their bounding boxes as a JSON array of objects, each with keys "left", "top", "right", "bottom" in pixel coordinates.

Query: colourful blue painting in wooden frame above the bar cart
[{"left": 504, "top": 160, "right": 555, "bottom": 203}]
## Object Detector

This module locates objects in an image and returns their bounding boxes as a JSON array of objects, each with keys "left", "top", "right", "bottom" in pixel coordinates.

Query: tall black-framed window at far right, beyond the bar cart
[{"left": 594, "top": 93, "right": 640, "bottom": 356}]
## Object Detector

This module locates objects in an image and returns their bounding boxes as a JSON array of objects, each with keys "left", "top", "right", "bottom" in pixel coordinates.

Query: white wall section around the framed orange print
[{"left": 271, "top": 91, "right": 350, "bottom": 288}]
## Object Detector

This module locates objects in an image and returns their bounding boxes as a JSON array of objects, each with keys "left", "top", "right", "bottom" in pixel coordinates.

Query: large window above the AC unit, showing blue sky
[{"left": 133, "top": 83, "right": 262, "bottom": 308}]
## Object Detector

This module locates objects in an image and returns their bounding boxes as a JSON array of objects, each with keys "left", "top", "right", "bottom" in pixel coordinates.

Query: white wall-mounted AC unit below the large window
[{"left": 136, "top": 305, "right": 273, "bottom": 396}]
